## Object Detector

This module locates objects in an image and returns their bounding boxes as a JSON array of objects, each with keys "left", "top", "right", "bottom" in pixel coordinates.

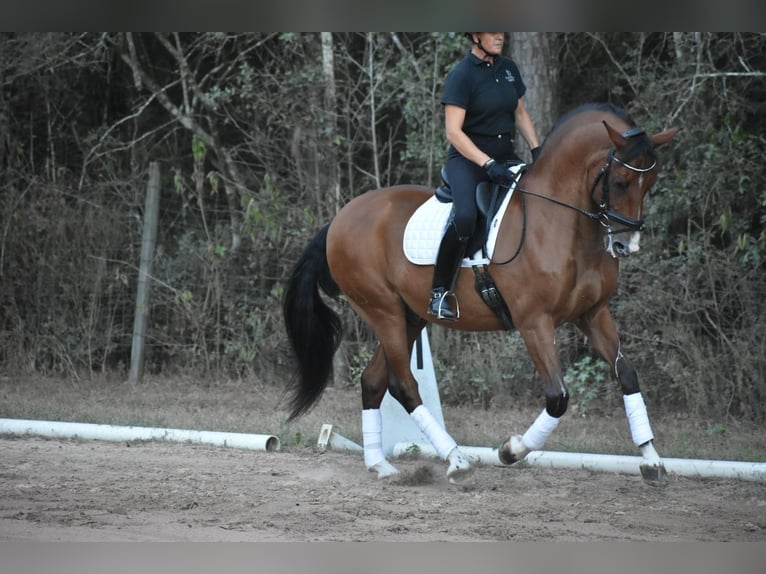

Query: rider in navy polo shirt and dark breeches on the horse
[{"left": 428, "top": 32, "right": 540, "bottom": 321}]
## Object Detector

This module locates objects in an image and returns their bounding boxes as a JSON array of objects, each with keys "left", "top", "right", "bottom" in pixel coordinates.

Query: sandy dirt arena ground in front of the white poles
[{"left": 0, "top": 438, "right": 766, "bottom": 542}]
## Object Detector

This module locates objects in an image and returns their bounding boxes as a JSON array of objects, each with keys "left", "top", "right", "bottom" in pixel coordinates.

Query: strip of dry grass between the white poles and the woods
[{"left": 0, "top": 376, "right": 766, "bottom": 462}]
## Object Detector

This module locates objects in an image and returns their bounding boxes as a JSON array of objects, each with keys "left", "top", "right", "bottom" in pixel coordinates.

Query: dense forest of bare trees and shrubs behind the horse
[{"left": 0, "top": 32, "right": 766, "bottom": 422}]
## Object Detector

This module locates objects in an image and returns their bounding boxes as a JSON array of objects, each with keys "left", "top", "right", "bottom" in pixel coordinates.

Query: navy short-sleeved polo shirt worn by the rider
[{"left": 441, "top": 52, "right": 527, "bottom": 136}]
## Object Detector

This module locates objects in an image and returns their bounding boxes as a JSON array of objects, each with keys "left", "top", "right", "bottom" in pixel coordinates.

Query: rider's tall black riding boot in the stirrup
[{"left": 428, "top": 223, "right": 468, "bottom": 321}]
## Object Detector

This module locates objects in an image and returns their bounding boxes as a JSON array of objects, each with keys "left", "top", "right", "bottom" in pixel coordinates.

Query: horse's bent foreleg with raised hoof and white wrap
[{"left": 498, "top": 321, "right": 569, "bottom": 464}]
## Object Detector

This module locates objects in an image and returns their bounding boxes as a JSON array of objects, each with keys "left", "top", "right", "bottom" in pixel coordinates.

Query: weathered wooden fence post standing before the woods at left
[{"left": 129, "top": 161, "right": 160, "bottom": 383}]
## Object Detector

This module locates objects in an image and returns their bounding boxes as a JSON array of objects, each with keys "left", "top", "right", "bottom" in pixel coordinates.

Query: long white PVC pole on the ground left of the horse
[{"left": 0, "top": 419, "right": 281, "bottom": 452}]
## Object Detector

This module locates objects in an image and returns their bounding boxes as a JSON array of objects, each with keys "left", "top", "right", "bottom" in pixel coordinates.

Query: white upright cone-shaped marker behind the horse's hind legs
[{"left": 380, "top": 329, "right": 446, "bottom": 457}]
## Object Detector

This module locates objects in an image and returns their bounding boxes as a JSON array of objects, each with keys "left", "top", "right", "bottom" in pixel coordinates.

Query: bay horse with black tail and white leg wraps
[{"left": 282, "top": 103, "right": 678, "bottom": 483}]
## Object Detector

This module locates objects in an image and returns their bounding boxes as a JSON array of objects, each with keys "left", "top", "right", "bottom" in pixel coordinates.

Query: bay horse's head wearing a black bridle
[{"left": 591, "top": 120, "right": 678, "bottom": 257}]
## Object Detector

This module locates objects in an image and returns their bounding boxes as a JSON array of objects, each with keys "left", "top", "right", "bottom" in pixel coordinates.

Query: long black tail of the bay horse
[{"left": 282, "top": 225, "right": 343, "bottom": 422}]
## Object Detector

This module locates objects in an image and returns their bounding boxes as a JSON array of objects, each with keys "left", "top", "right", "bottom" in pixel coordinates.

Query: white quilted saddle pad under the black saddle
[{"left": 403, "top": 173, "right": 518, "bottom": 267}]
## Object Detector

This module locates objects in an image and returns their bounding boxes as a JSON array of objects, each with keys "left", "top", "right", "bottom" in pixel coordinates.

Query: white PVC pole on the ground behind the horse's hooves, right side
[{"left": 394, "top": 442, "right": 766, "bottom": 482}]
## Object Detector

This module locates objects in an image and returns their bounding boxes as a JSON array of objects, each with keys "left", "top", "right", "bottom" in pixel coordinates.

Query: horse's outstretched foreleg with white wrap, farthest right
[{"left": 578, "top": 307, "right": 667, "bottom": 483}]
